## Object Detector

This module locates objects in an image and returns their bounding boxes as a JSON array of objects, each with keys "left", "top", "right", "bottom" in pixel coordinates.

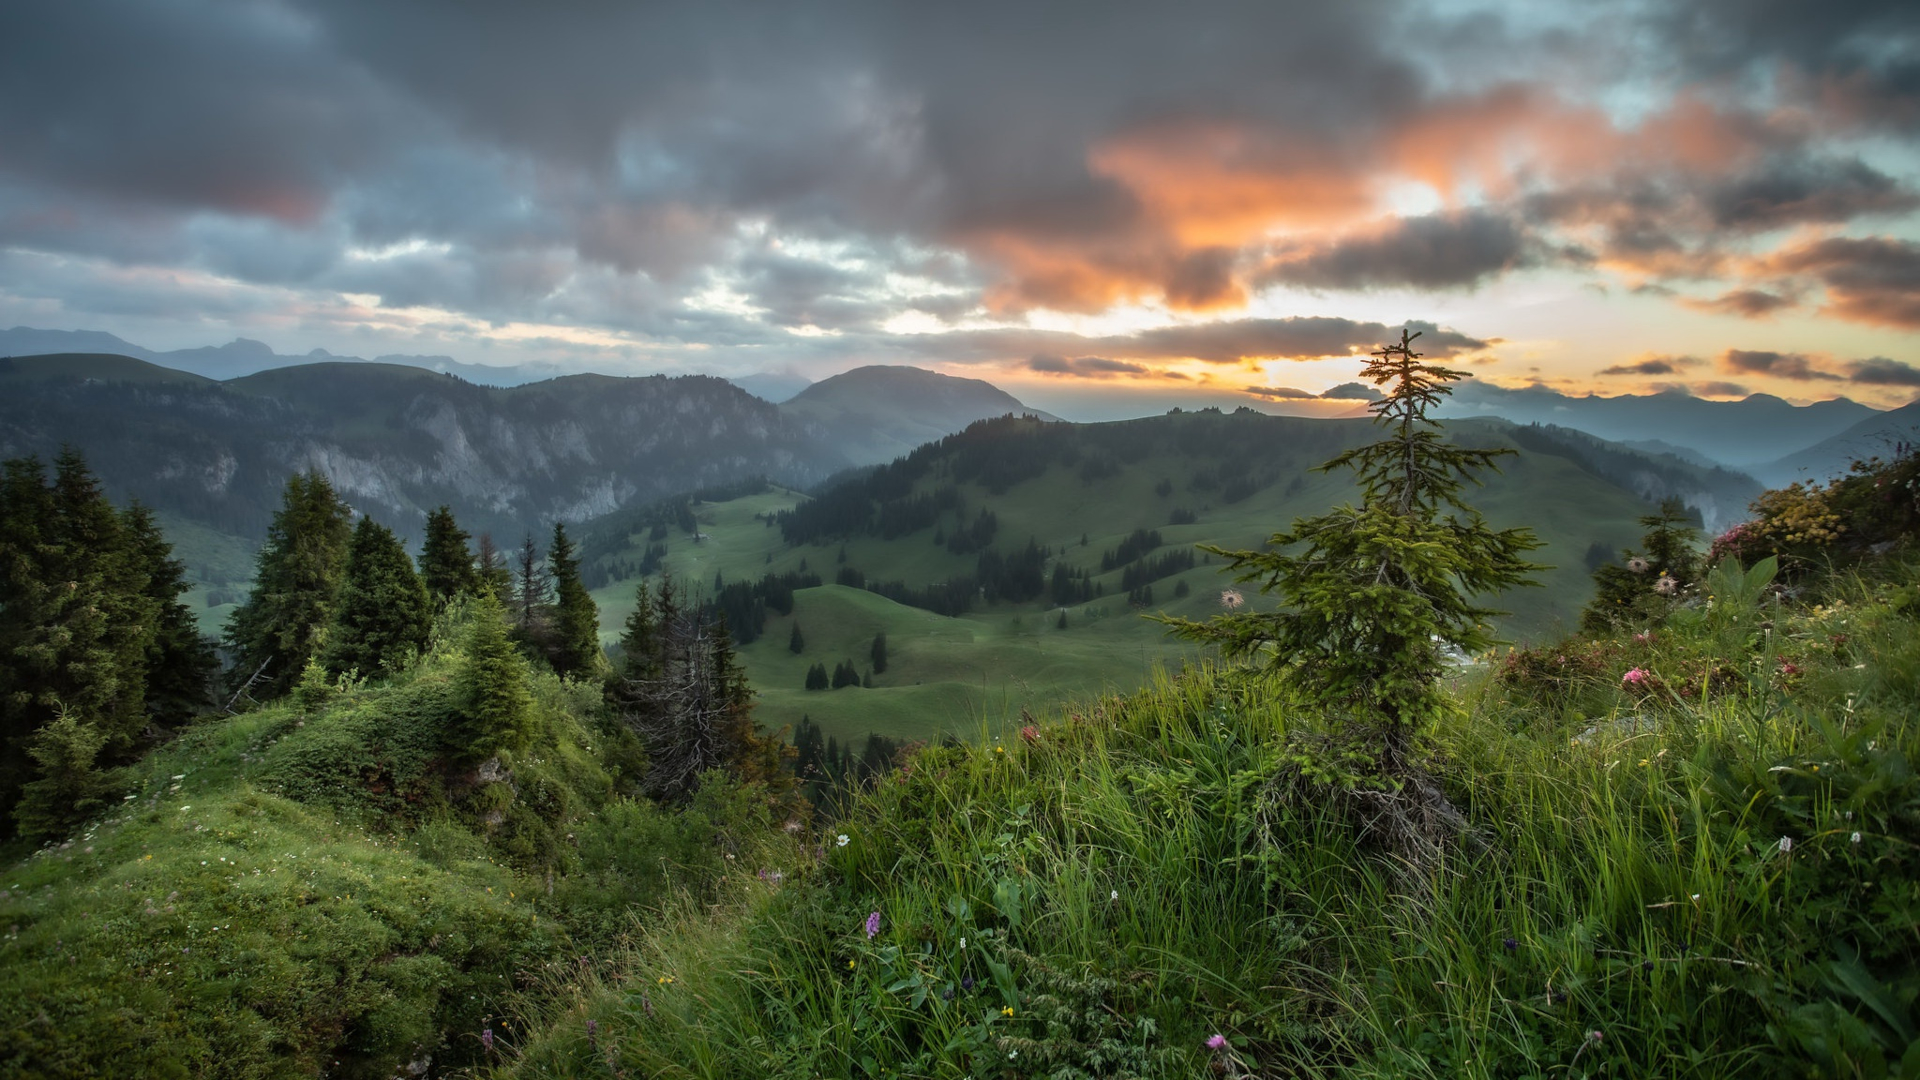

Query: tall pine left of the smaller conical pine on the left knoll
[{"left": 227, "top": 473, "right": 353, "bottom": 696}]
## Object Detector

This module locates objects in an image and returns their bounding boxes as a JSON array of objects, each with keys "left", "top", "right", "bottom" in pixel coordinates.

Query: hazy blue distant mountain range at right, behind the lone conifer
[{"left": 1440, "top": 379, "right": 1878, "bottom": 467}]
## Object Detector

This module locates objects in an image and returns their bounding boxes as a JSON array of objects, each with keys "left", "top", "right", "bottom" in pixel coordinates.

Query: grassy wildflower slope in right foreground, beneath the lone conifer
[{"left": 497, "top": 559, "right": 1920, "bottom": 1078}]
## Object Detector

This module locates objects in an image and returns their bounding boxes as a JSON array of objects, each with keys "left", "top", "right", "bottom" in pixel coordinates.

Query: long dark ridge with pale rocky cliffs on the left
[{"left": 0, "top": 354, "right": 847, "bottom": 546}]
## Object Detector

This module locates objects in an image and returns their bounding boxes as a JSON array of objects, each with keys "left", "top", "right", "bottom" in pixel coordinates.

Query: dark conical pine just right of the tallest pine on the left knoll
[{"left": 321, "top": 517, "right": 434, "bottom": 675}]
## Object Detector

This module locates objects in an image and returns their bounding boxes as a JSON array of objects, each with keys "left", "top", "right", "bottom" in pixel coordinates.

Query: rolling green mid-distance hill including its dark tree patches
[{"left": 582, "top": 409, "right": 1759, "bottom": 742}]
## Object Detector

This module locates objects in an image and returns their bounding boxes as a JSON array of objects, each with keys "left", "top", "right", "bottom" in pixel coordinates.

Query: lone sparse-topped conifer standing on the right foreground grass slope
[{"left": 1167, "top": 322, "right": 1542, "bottom": 778}]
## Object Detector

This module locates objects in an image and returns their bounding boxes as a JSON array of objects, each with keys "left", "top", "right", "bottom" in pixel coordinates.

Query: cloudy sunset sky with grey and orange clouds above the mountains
[{"left": 0, "top": 0, "right": 1920, "bottom": 419}]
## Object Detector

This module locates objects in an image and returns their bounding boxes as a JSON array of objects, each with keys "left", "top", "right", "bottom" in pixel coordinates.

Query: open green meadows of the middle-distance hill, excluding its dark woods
[{"left": 588, "top": 411, "right": 1743, "bottom": 740}]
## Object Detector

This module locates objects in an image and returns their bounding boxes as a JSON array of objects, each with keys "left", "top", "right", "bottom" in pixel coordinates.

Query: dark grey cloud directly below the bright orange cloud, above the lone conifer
[{"left": 1258, "top": 209, "right": 1538, "bottom": 288}]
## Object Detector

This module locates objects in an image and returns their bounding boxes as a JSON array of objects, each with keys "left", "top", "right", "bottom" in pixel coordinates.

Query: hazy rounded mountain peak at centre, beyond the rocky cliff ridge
[{"left": 780, "top": 365, "right": 1060, "bottom": 465}]
